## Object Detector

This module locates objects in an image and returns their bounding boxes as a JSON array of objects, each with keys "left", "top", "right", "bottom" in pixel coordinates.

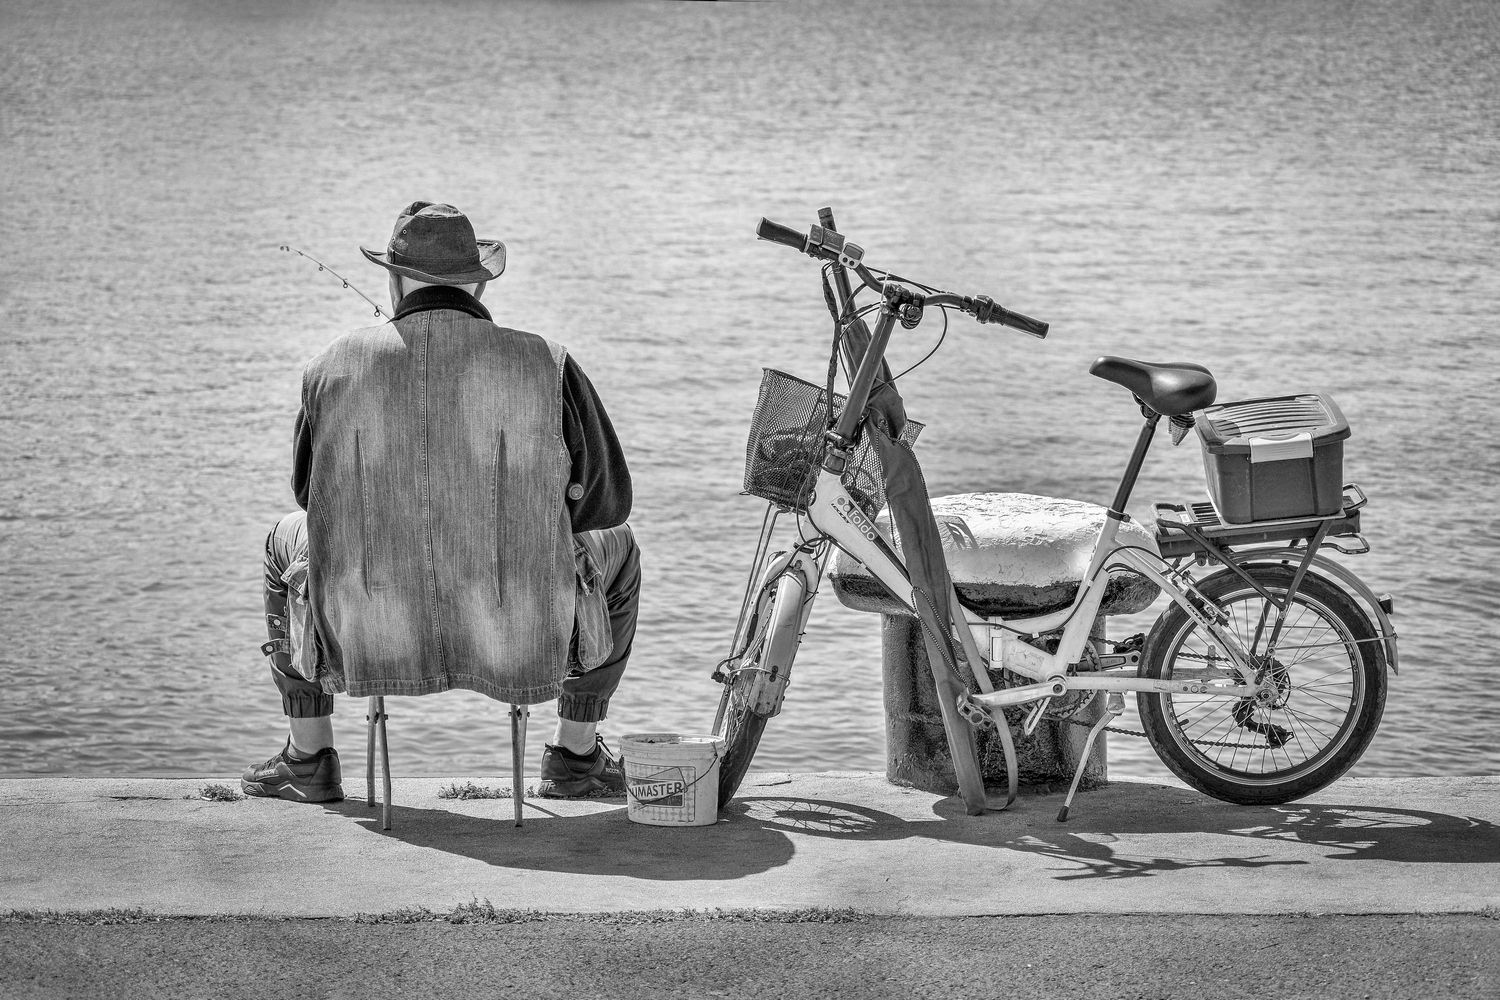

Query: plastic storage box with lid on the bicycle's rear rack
[{"left": 1197, "top": 394, "right": 1349, "bottom": 525}]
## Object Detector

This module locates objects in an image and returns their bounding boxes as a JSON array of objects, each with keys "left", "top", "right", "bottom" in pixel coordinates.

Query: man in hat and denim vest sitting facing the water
[{"left": 240, "top": 201, "right": 641, "bottom": 802}]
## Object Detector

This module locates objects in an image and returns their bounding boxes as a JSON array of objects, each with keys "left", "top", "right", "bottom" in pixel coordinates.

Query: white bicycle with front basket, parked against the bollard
[{"left": 714, "top": 210, "right": 1397, "bottom": 820}]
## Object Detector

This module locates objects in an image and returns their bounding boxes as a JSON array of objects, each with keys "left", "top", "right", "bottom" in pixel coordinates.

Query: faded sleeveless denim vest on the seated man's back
[{"left": 303, "top": 309, "right": 578, "bottom": 705}]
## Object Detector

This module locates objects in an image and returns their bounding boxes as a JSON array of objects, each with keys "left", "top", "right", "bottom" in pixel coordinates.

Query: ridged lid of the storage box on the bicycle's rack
[{"left": 1196, "top": 393, "right": 1349, "bottom": 462}]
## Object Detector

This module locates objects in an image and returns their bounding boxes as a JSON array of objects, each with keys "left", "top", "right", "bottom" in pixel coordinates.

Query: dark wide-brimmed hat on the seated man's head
[{"left": 360, "top": 201, "right": 506, "bottom": 285}]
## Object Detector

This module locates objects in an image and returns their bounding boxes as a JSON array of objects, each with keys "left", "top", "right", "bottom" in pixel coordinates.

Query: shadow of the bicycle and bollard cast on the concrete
[{"left": 725, "top": 783, "right": 1500, "bottom": 880}]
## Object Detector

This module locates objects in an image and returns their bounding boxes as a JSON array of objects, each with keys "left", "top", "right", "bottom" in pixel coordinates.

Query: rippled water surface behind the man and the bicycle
[{"left": 0, "top": 0, "right": 1500, "bottom": 775}]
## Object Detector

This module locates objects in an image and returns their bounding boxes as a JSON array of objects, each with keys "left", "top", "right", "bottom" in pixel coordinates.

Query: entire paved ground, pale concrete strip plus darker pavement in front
[{"left": 0, "top": 759, "right": 1500, "bottom": 1000}]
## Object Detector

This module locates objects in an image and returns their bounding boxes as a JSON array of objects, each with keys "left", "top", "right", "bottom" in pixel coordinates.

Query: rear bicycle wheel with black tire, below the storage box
[{"left": 1137, "top": 565, "right": 1386, "bottom": 805}]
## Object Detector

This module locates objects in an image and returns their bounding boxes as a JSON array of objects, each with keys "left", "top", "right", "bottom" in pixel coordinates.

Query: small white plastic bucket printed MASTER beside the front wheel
[{"left": 621, "top": 733, "right": 725, "bottom": 826}]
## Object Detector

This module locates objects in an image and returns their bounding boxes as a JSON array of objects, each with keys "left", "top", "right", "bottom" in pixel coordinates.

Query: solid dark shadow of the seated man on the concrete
[{"left": 310, "top": 799, "right": 794, "bottom": 882}]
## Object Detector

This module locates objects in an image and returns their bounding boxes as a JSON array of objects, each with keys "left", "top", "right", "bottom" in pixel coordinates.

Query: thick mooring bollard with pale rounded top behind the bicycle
[{"left": 830, "top": 493, "right": 1158, "bottom": 795}]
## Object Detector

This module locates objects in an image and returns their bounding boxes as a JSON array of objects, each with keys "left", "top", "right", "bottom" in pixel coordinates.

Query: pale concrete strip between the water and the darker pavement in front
[{"left": 0, "top": 771, "right": 1500, "bottom": 918}]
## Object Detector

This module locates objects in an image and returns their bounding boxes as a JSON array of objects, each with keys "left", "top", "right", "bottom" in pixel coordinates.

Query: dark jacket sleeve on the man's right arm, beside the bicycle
[{"left": 563, "top": 355, "right": 633, "bottom": 531}]
